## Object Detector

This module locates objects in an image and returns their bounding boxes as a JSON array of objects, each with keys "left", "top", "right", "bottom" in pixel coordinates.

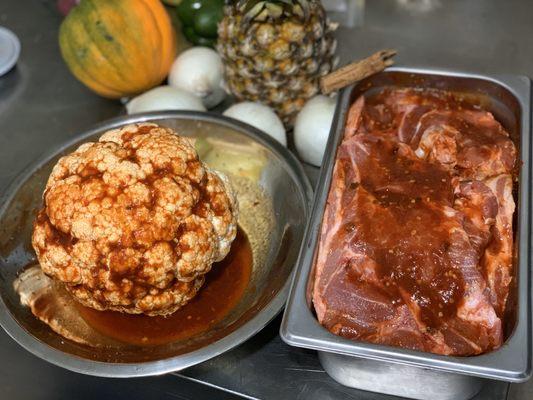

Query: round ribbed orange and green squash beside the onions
[{"left": 59, "top": 0, "right": 176, "bottom": 98}]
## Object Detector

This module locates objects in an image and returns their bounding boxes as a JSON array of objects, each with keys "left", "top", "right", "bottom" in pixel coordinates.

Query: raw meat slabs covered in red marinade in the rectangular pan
[{"left": 313, "top": 88, "right": 516, "bottom": 356}]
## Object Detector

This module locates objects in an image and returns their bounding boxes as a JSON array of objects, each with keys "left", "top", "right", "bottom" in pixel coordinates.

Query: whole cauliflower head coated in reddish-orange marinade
[{"left": 32, "top": 123, "right": 237, "bottom": 315}]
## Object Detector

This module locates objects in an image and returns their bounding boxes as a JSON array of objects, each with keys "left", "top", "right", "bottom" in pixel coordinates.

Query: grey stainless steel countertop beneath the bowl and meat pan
[{"left": 0, "top": 0, "right": 533, "bottom": 400}]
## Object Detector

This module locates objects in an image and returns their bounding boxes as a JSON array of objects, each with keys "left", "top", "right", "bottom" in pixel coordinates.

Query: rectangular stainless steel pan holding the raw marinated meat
[{"left": 280, "top": 68, "right": 531, "bottom": 399}]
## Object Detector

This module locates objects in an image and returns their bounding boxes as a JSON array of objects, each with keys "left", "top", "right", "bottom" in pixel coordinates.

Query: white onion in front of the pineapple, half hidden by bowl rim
[{"left": 223, "top": 101, "right": 287, "bottom": 146}]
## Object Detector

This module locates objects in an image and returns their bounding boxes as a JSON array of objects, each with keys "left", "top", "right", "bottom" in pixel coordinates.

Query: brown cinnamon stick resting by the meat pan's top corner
[{"left": 320, "top": 49, "right": 396, "bottom": 94}]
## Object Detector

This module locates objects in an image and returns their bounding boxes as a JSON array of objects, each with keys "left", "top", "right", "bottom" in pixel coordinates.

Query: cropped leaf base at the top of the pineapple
[{"left": 233, "top": 0, "right": 316, "bottom": 24}]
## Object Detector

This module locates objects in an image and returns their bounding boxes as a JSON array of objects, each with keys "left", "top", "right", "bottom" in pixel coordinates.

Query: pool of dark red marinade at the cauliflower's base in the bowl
[{"left": 75, "top": 228, "right": 253, "bottom": 346}]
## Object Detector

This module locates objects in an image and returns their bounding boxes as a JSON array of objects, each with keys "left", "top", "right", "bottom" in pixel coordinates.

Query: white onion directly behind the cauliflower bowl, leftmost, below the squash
[{"left": 126, "top": 86, "right": 205, "bottom": 114}]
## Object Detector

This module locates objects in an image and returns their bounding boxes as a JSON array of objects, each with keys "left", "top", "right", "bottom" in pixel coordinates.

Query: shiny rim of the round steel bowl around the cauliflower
[{"left": 0, "top": 111, "right": 313, "bottom": 378}]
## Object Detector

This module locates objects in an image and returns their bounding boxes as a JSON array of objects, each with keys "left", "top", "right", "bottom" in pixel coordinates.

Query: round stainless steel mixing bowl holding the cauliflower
[{"left": 0, "top": 111, "right": 312, "bottom": 377}]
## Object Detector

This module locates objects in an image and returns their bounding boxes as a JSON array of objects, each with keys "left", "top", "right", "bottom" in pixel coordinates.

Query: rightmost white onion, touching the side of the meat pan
[{"left": 294, "top": 95, "right": 336, "bottom": 166}]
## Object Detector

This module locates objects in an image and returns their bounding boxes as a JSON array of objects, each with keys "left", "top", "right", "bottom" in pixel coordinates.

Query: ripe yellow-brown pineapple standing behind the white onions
[{"left": 217, "top": 0, "right": 337, "bottom": 127}]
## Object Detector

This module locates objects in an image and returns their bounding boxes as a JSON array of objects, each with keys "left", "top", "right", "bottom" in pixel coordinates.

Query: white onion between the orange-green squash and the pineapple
[{"left": 168, "top": 46, "right": 226, "bottom": 108}]
